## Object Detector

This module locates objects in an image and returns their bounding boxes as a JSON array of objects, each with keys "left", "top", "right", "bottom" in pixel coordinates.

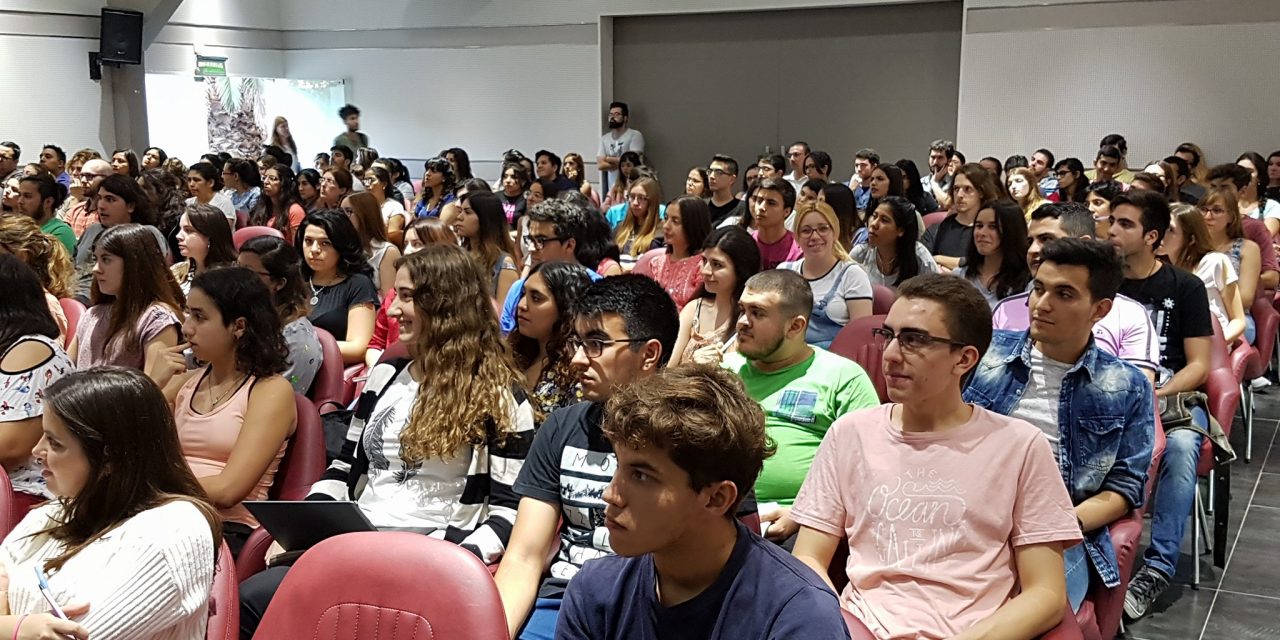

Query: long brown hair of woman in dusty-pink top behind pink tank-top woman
[{"left": 90, "top": 224, "right": 185, "bottom": 353}]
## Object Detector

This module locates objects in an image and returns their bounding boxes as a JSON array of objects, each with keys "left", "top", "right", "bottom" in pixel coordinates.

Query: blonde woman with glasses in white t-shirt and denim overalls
[{"left": 778, "top": 201, "right": 872, "bottom": 348}]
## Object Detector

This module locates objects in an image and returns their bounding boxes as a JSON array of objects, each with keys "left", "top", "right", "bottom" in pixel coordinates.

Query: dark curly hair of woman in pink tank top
[{"left": 191, "top": 266, "right": 289, "bottom": 378}]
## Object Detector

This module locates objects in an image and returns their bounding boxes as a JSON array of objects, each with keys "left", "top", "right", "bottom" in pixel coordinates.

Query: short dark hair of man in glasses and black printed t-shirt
[{"left": 578, "top": 273, "right": 680, "bottom": 365}]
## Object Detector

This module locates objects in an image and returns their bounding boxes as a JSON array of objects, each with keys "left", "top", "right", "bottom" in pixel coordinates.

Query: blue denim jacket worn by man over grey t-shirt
[{"left": 964, "top": 332, "right": 1156, "bottom": 588}]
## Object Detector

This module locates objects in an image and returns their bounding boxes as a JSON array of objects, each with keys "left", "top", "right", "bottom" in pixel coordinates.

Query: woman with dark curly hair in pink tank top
[{"left": 147, "top": 266, "right": 297, "bottom": 556}]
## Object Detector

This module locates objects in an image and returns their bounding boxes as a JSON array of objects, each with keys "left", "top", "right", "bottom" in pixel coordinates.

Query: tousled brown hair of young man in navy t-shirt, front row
[{"left": 603, "top": 365, "right": 777, "bottom": 520}]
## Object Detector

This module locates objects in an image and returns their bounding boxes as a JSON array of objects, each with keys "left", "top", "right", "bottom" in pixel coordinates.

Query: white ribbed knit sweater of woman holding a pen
[{"left": 0, "top": 500, "right": 216, "bottom": 640}]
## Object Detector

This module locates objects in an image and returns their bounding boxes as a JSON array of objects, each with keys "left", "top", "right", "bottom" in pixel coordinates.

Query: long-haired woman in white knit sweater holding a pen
[{"left": 0, "top": 366, "right": 221, "bottom": 640}]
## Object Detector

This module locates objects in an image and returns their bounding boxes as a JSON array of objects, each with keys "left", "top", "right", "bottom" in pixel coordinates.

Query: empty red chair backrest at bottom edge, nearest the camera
[{"left": 255, "top": 531, "right": 508, "bottom": 640}]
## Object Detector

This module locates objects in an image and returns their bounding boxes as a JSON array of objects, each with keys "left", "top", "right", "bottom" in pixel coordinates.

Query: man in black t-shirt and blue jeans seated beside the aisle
[{"left": 1108, "top": 189, "right": 1213, "bottom": 618}]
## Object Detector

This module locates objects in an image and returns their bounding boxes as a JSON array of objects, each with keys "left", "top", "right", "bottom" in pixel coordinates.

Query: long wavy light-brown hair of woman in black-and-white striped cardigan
[{"left": 396, "top": 244, "right": 525, "bottom": 463}]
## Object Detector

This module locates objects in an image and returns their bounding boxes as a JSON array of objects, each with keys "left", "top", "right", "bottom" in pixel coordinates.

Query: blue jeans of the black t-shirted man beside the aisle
[{"left": 1142, "top": 407, "right": 1208, "bottom": 577}]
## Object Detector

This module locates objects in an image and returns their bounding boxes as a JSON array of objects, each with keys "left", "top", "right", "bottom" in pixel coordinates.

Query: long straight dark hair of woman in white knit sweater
[{"left": 35, "top": 368, "right": 221, "bottom": 571}]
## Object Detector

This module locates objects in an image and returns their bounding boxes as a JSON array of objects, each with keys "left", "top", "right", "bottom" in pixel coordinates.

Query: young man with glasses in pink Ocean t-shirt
[{"left": 791, "top": 274, "right": 1082, "bottom": 639}]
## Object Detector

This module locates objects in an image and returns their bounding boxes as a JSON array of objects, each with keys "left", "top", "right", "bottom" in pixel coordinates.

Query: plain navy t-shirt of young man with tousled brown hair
[{"left": 556, "top": 524, "right": 849, "bottom": 640}]
